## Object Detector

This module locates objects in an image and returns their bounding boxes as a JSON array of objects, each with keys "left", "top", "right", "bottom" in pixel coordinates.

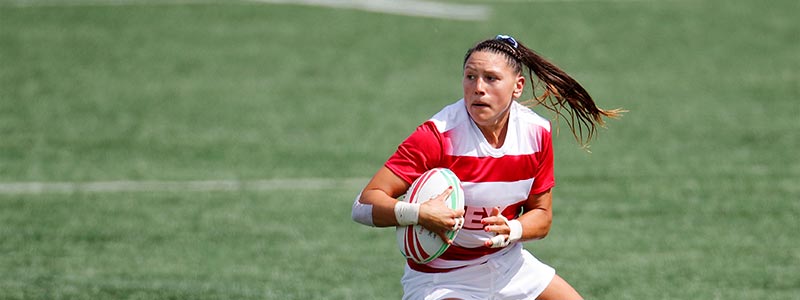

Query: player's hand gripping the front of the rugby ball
[{"left": 417, "top": 187, "right": 464, "bottom": 244}]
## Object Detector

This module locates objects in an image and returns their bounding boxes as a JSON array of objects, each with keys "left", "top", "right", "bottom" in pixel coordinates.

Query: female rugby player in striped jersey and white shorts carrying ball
[{"left": 352, "top": 35, "right": 621, "bottom": 300}]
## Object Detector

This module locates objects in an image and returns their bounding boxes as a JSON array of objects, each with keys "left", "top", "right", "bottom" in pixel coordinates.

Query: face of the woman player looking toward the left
[{"left": 462, "top": 51, "right": 525, "bottom": 128}]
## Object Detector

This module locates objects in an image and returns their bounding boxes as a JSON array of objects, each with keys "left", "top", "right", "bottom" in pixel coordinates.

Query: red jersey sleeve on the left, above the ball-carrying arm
[{"left": 384, "top": 121, "right": 443, "bottom": 184}]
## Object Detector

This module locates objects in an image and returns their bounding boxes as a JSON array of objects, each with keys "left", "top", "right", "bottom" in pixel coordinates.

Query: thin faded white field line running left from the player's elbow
[{"left": 0, "top": 178, "right": 369, "bottom": 195}]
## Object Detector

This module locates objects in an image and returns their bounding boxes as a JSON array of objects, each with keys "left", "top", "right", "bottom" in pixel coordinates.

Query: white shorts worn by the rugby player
[{"left": 401, "top": 243, "right": 556, "bottom": 300}]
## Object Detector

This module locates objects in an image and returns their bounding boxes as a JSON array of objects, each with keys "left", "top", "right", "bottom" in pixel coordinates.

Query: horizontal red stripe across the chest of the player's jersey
[{"left": 445, "top": 154, "right": 539, "bottom": 182}]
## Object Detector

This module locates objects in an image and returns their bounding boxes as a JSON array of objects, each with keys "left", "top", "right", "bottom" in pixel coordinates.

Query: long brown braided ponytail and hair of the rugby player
[{"left": 464, "top": 35, "right": 626, "bottom": 146}]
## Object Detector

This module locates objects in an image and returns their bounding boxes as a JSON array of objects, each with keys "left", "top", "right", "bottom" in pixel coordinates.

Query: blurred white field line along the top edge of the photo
[{"left": 0, "top": 0, "right": 491, "bottom": 21}]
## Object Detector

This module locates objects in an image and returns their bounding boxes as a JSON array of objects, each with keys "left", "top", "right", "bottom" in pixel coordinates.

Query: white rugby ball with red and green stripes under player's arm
[{"left": 397, "top": 168, "right": 464, "bottom": 264}]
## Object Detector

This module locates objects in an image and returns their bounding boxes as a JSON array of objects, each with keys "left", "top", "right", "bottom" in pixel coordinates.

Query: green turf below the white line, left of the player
[{"left": 0, "top": 190, "right": 402, "bottom": 299}]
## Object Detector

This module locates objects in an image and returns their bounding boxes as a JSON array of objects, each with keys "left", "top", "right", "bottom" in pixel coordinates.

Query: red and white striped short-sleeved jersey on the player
[{"left": 385, "top": 99, "right": 555, "bottom": 272}]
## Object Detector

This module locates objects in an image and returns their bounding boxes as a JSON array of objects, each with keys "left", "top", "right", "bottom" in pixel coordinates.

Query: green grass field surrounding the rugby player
[{"left": 0, "top": 0, "right": 800, "bottom": 299}]
